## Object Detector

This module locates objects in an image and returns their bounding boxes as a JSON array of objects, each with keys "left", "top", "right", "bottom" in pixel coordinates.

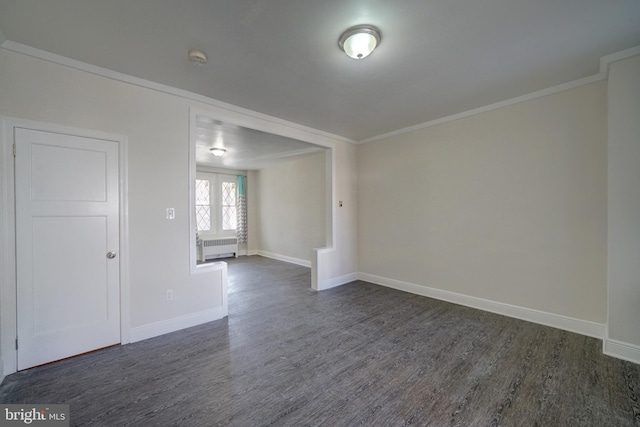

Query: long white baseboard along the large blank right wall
[{"left": 358, "top": 273, "right": 605, "bottom": 339}]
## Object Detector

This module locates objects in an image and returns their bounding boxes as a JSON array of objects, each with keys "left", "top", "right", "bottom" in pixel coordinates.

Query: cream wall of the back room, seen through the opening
[{"left": 255, "top": 152, "right": 327, "bottom": 266}]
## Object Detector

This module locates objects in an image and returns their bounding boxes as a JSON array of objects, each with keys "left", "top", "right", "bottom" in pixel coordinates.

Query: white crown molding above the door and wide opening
[{"left": 0, "top": 40, "right": 356, "bottom": 144}]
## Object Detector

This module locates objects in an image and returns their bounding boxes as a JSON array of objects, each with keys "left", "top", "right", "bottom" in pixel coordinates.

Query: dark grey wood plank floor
[{"left": 0, "top": 256, "right": 640, "bottom": 427}]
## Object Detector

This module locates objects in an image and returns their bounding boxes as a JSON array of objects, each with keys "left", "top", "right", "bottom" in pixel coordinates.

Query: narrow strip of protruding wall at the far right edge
[{"left": 605, "top": 56, "right": 640, "bottom": 363}]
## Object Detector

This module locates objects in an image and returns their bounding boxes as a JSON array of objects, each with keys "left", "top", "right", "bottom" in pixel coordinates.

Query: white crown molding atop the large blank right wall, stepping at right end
[{"left": 356, "top": 46, "right": 640, "bottom": 145}]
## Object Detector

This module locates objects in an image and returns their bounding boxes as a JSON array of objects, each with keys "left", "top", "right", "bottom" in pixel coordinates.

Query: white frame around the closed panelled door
[{"left": 0, "top": 116, "right": 131, "bottom": 381}]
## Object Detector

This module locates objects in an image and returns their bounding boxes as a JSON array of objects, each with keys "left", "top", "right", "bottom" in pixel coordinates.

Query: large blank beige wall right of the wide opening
[{"left": 358, "top": 82, "right": 607, "bottom": 329}]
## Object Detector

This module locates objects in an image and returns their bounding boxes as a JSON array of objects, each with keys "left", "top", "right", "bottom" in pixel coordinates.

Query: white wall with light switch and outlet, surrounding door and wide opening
[{"left": 0, "top": 49, "right": 356, "bottom": 372}]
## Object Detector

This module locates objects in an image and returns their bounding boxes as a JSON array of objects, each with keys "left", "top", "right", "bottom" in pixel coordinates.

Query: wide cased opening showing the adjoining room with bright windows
[{"left": 189, "top": 110, "right": 333, "bottom": 282}]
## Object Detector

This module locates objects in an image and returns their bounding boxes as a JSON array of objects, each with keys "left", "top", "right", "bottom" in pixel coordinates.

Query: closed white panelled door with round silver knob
[{"left": 15, "top": 129, "right": 120, "bottom": 370}]
